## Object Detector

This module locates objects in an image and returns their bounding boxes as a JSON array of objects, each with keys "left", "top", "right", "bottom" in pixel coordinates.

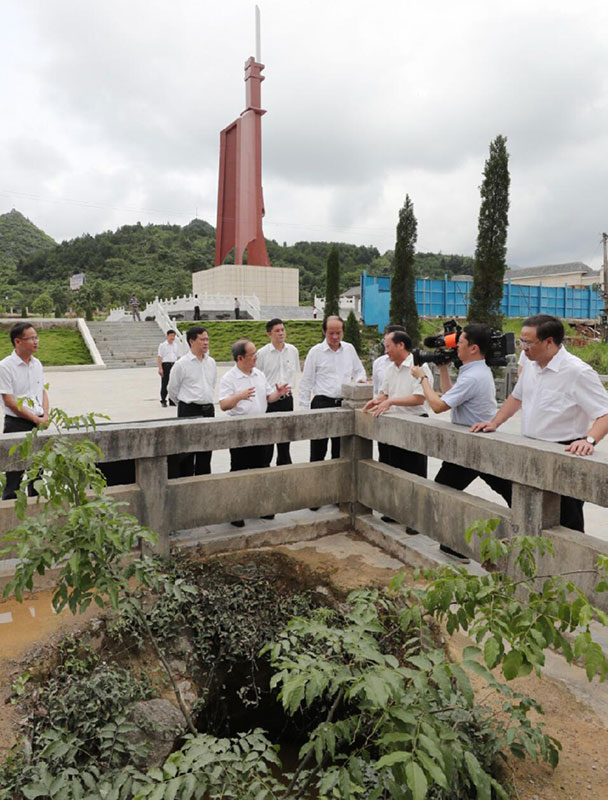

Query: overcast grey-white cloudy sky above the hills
[{"left": 0, "top": 0, "right": 608, "bottom": 267}]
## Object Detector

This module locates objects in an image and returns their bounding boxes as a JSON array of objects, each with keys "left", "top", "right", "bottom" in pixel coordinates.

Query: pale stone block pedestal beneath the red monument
[{"left": 192, "top": 264, "right": 300, "bottom": 306}]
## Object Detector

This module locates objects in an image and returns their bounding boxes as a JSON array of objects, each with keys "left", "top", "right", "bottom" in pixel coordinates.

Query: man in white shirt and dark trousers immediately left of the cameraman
[{"left": 363, "top": 330, "right": 428, "bottom": 536}]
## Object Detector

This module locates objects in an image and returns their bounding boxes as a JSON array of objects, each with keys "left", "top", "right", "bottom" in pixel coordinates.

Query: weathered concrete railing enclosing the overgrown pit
[{"left": 0, "top": 385, "right": 608, "bottom": 610}]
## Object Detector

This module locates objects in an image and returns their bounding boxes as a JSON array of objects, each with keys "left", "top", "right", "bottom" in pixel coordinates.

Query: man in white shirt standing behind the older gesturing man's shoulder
[{"left": 257, "top": 318, "right": 300, "bottom": 467}]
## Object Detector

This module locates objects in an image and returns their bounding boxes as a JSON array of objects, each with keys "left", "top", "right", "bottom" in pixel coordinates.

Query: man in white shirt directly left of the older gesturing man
[{"left": 167, "top": 325, "right": 217, "bottom": 478}]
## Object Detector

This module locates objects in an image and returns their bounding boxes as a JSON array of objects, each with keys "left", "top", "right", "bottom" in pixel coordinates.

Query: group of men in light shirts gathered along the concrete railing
[{"left": 0, "top": 315, "right": 608, "bottom": 561}]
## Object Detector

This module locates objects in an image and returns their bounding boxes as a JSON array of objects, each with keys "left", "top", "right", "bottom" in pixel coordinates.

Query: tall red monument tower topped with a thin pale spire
[{"left": 215, "top": 7, "right": 270, "bottom": 267}]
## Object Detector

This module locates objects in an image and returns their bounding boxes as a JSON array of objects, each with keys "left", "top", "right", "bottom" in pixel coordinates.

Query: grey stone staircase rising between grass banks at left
[{"left": 87, "top": 321, "right": 163, "bottom": 369}]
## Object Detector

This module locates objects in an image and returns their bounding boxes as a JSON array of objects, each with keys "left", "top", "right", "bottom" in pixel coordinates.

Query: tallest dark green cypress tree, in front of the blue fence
[{"left": 468, "top": 136, "right": 511, "bottom": 328}]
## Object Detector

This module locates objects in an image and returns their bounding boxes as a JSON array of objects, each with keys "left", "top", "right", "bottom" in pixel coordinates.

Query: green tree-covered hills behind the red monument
[{"left": 0, "top": 211, "right": 472, "bottom": 311}]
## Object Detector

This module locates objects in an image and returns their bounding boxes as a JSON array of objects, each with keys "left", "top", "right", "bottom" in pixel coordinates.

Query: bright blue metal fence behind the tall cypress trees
[{"left": 361, "top": 271, "right": 603, "bottom": 330}]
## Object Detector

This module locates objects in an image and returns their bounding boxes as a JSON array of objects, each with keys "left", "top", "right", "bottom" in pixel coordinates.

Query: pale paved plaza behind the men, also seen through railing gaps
[{"left": 2, "top": 364, "right": 608, "bottom": 541}]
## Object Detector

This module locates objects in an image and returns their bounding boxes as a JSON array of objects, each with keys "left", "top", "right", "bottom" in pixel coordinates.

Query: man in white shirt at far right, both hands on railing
[{"left": 471, "top": 314, "right": 608, "bottom": 533}]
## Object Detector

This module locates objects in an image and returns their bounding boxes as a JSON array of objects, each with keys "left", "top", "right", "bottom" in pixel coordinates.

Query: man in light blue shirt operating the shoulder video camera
[{"left": 412, "top": 324, "right": 511, "bottom": 564}]
